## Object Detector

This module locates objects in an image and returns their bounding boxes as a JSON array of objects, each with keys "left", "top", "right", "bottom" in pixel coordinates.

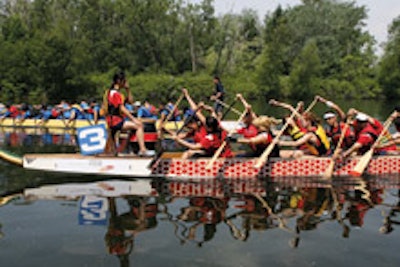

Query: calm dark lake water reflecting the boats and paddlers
[{"left": 0, "top": 99, "right": 400, "bottom": 267}]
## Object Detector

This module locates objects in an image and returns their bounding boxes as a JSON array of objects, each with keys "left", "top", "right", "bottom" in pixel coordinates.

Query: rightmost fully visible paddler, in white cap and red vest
[{"left": 342, "top": 109, "right": 396, "bottom": 157}]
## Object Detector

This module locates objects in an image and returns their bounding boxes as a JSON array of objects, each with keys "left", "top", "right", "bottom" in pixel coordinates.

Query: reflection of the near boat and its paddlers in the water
[{"left": 0, "top": 177, "right": 400, "bottom": 266}]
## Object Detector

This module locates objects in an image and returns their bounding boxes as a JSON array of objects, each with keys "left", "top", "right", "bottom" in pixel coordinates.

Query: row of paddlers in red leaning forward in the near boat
[{"left": 167, "top": 89, "right": 400, "bottom": 162}]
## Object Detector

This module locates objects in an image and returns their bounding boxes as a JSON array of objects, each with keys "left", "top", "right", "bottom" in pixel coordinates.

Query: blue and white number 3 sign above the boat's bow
[{"left": 77, "top": 124, "right": 107, "bottom": 155}]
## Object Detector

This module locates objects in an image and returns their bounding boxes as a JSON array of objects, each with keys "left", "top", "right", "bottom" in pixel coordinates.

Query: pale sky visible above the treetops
[{"left": 189, "top": 0, "right": 400, "bottom": 53}]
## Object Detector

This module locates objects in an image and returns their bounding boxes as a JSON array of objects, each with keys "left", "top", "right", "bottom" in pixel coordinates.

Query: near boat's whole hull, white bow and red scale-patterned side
[{"left": 16, "top": 153, "right": 400, "bottom": 179}]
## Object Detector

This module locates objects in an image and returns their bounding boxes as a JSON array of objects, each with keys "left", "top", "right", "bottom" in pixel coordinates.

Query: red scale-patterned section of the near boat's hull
[{"left": 153, "top": 156, "right": 400, "bottom": 179}]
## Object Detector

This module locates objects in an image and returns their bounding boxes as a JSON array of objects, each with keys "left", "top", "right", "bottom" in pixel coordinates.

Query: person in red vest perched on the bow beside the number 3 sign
[{"left": 106, "top": 74, "right": 153, "bottom": 156}]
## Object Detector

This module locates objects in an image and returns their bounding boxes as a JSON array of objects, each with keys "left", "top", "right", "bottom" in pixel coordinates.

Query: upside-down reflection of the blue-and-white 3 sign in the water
[{"left": 78, "top": 196, "right": 109, "bottom": 225}]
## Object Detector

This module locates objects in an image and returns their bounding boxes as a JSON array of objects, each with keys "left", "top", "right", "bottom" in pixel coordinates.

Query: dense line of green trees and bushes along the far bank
[{"left": 0, "top": 0, "right": 400, "bottom": 103}]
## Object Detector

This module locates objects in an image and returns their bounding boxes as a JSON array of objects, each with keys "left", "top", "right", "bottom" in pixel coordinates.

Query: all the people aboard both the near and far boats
[{"left": 0, "top": 72, "right": 400, "bottom": 158}]
